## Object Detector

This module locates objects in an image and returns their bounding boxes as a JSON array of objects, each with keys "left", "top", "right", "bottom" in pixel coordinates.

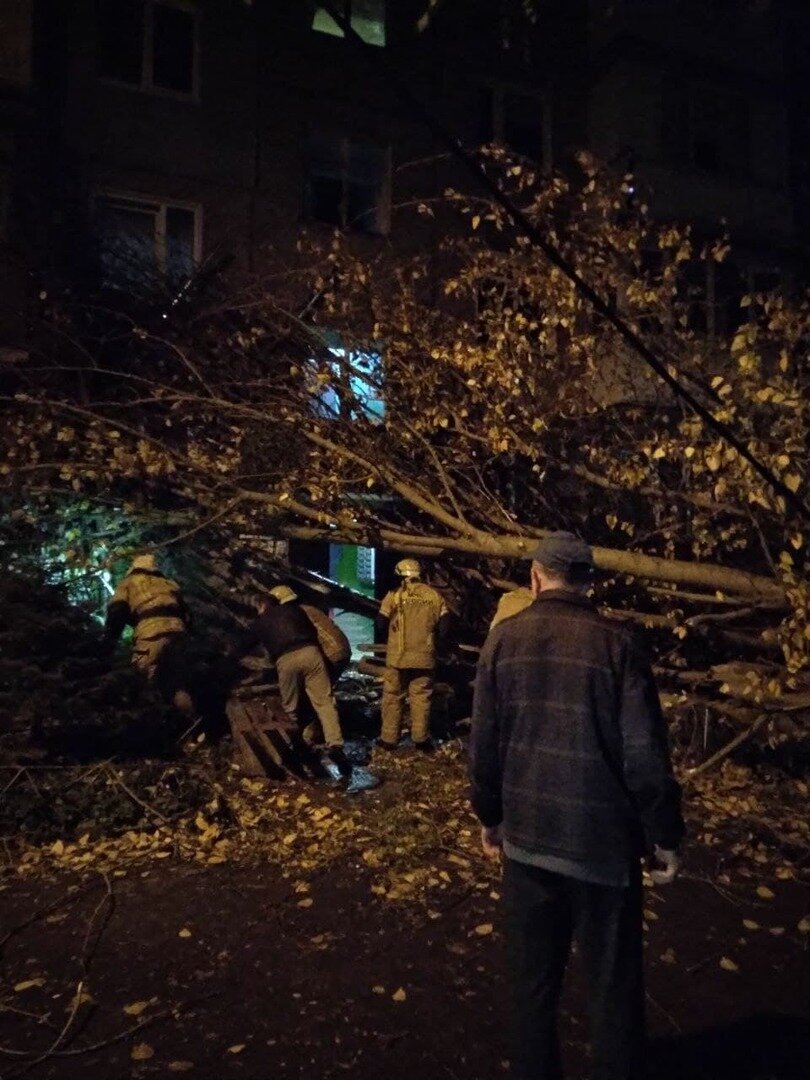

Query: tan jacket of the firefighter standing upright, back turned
[{"left": 380, "top": 581, "right": 448, "bottom": 670}]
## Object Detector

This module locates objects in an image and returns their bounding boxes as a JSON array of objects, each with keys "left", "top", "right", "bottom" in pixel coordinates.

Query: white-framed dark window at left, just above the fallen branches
[{"left": 95, "top": 194, "right": 201, "bottom": 293}]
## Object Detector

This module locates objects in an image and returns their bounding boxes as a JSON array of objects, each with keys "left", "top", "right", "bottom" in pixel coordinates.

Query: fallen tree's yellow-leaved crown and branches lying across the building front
[{"left": 2, "top": 150, "right": 810, "bottom": 696}]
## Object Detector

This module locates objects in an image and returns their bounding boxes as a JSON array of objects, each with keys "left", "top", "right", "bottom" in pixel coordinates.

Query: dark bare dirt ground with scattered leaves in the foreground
[{"left": 0, "top": 755, "right": 810, "bottom": 1080}]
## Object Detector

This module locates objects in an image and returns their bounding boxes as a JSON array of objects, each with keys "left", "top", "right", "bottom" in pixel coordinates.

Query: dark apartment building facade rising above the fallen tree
[{"left": 0, "top": 0, "right": 810, "bottom": 630}]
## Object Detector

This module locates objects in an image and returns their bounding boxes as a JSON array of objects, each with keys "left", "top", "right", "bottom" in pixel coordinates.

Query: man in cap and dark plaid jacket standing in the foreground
[{"left": 471, "top": 532, "right": 684, "bottom": 1080}]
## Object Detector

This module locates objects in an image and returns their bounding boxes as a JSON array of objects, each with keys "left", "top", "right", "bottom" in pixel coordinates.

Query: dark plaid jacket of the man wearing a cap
[{"left": 470, "top": 590, "right": 684, "bottom": 863}]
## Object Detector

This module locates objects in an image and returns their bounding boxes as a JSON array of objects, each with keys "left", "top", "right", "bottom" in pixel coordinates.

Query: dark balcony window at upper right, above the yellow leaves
[{"left": 662, "top": 78, "right": 751, "bottom": 175}]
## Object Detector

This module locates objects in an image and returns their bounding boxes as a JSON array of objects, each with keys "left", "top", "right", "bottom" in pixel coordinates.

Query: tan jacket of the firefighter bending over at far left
[{"left": 105, "top": 569, "right": 188, "bottom": 649}]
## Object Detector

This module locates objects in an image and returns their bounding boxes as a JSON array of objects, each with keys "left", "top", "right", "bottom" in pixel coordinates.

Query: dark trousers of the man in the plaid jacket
[{"left": 503, "top": 859, "right": 644, "bottom": 1080}]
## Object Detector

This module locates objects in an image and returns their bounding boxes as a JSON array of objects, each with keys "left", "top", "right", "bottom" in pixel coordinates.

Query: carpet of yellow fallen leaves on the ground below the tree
[{"left": 0, "top": 742, "right": 808, "bottom": 924}]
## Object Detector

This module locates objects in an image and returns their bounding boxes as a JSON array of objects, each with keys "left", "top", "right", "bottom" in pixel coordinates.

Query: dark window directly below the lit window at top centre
[{"left": 306, "top": 133, "right": 390, "bottom": 233}]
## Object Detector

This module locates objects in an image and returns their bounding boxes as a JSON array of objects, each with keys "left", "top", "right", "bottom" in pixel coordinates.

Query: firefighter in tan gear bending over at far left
[{"left": 105, "top": 554, "right": 193, "bottom": 714}]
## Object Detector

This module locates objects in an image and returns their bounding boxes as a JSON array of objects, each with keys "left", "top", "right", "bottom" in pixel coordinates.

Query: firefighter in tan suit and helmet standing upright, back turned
[{"left": 377, "top": 558, "right": 449, "bottom": 751}]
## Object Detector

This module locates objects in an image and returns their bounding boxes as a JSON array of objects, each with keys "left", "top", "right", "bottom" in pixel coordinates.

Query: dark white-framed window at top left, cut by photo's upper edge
[{"left": 97, "top": 0, "right": 199, "bottom": 97}]
